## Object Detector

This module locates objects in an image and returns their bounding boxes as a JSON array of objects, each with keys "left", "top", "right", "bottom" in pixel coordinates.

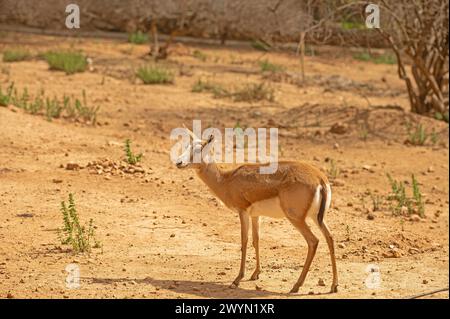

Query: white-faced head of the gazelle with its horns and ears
[{"left": 175, "top": 128, "right": 214, "bottom": 168}]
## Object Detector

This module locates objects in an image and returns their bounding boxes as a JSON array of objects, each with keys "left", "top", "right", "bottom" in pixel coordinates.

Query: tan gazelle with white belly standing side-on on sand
[{"left": 176, "top": 128, "right": 338, "bottom": 293}]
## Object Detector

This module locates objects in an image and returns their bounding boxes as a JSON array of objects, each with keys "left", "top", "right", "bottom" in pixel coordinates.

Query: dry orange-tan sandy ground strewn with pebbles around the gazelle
[{"left": 0, "top": 33, "right": 449, "bottom": 298}]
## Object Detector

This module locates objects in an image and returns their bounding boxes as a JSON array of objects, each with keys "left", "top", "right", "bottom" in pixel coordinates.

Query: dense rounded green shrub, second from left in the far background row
[{"left": 43, "top": 51, "right": 88, "bottom": 74}]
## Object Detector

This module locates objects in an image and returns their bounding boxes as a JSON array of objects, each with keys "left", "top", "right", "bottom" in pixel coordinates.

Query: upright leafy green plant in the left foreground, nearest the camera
[{"left": 58, "top": 193, "right": 100, "bottom": 253}]
